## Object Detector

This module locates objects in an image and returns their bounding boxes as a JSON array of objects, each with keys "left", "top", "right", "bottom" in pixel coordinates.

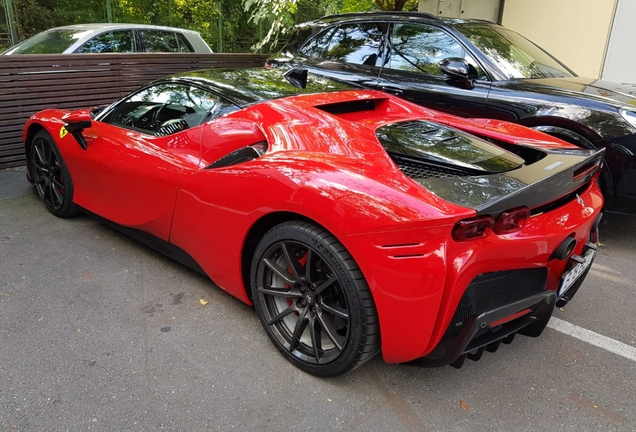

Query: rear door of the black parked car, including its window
[{"left": 290, "top": 22, "right": 388, "bottom": 88}]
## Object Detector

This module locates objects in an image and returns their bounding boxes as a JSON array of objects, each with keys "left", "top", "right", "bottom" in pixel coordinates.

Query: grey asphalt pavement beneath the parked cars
[{"left": 0, "top": 170, "right": 636, "bottom": 432}]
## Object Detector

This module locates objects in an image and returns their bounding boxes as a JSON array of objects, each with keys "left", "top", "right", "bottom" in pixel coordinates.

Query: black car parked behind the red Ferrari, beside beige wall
[{"left": 269, "top": 12, "right": 636, "bottom": 213}]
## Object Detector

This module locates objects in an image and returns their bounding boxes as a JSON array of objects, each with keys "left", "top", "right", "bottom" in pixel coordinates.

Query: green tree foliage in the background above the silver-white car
[{"left": 8, "top": 0, "right": 417, "bottom": 51}]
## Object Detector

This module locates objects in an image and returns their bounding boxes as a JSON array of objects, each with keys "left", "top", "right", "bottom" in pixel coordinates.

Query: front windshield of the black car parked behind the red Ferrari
[{"left": 457, "top": 24, "right": 572, "bottom": 78}]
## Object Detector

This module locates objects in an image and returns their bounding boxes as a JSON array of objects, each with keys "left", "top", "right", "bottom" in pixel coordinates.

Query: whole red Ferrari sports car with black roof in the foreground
[{"left": 23, "top": 69, "right": 603, "bottom": 376}]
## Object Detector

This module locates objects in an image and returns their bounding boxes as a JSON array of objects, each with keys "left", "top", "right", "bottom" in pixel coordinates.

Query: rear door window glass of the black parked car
[{"left": 323, "top": 23, "right": 386, "bottom": 66}]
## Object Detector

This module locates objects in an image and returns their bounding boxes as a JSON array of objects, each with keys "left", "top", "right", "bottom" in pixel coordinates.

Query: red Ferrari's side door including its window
[{"left": 73, "top": 83, "right": 217, "bottom": 241}]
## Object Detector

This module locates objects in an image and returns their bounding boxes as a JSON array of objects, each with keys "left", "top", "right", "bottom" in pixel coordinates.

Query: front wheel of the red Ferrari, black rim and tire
[{"left": 29, "top": 130, "right": 79, "bottom": 218}]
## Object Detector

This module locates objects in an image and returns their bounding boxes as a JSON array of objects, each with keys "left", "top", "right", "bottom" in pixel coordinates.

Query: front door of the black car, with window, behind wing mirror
[{"left": 378, "top": 23, "right": 491, "bottom": 117}]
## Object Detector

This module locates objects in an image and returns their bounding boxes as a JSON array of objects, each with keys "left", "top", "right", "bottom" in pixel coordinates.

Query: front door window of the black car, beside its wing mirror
[{"left": 387, "top": 24, "right": 484, "bottom": 77}]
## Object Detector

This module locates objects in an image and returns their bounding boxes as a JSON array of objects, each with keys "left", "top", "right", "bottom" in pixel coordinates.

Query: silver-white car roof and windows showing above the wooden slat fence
[{"left": 3, "top": 24, "right": 212, "bottom": 55}]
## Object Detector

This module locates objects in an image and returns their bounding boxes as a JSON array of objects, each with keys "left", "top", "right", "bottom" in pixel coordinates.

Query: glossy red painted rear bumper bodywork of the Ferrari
[{"left": 342, "top": 177, "right": 603, "bottom": 364}]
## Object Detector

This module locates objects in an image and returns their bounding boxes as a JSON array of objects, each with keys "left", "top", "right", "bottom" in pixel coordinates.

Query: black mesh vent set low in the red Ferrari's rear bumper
[{"left": 442, "top": 267, "right": 548, "bottom": 340}]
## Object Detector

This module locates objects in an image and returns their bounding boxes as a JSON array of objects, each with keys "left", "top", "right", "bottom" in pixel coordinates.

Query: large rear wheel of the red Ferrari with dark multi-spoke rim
[{"left": 251, "top": 221, "right": 380, "bottom": 377}]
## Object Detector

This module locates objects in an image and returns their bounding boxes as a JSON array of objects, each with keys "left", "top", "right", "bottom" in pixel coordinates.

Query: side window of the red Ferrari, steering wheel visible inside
[{"left": 102, "top": 83, "right": 219, "bottom": 136}]
